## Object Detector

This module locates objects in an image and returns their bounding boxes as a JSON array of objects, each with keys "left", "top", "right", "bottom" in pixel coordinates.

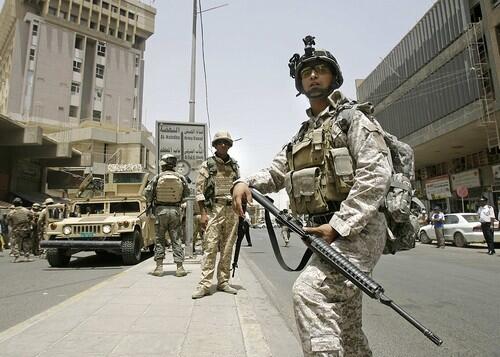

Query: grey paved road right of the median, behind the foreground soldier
[{"left": 242, "top": 229, "right": 500, "bottom": 357}]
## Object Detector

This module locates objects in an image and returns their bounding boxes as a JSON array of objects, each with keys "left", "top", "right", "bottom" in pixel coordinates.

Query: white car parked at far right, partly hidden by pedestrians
[{"left": 418, "top": 213, "right": 500, "bottom": 247}]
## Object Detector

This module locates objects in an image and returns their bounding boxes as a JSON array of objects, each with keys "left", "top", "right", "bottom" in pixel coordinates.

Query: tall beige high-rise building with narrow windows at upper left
[{"left": 0, "top": 0, "right": 156, "bottom": 195}]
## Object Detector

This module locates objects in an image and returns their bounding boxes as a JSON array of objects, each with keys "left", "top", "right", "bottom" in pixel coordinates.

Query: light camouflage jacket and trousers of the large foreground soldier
[{"left": 243, "top": 91, "right": 391, "bottom": 357}]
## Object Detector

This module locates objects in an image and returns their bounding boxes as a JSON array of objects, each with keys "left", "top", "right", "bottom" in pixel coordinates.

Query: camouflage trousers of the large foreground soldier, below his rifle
[{"left": 293, "top": 259, "right": 372, "bottom": 357}]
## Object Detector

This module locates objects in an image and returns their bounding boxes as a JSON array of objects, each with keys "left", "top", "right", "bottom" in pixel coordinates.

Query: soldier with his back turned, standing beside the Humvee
[{"left": 144, "top": 154, "right": 189, "bottom": 277}]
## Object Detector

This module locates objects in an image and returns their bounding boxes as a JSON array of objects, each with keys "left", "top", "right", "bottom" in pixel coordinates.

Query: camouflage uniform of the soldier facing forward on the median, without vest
[{"left": 196, "top": 156, "right": 239, "bottom": 289}]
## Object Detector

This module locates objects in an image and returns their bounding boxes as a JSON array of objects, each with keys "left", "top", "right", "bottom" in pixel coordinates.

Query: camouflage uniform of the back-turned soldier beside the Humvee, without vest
[{"left": 144, "top": 170, "right": 189, "bottom": 263}]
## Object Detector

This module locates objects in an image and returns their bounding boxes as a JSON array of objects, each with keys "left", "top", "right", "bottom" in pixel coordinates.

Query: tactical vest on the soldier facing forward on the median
[{"left": 204, "top": 157, "right": 239, "bottom": 208}]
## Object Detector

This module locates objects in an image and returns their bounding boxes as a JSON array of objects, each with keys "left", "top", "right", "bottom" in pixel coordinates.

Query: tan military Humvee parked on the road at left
[{"left": 41, "top": 164, "right": 155, "bottom": 267}]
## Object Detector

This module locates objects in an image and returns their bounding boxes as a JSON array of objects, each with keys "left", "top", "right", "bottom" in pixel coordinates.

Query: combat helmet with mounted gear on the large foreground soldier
[{"left": 288, "top": 35, "right": 344, "bottom": 95}]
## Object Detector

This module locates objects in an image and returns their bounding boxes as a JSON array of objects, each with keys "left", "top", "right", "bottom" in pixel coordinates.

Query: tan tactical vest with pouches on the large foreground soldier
[{"left": 285, "top": 118, "right": 354, "bottom": 215}]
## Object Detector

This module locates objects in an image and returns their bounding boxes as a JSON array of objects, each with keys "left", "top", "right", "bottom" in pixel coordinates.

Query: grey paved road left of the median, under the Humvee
[{"left": 0, "top": 250, "right": 151, "bottom": 331}]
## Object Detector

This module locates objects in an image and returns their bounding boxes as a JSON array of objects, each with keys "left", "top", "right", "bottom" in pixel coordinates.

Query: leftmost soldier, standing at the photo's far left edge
[{"left": 7, "top": 197, "right": 33, "bottom": 263}]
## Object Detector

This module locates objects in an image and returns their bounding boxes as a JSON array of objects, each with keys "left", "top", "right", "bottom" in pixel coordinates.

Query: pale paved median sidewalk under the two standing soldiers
[{"left": 0, "top": 252, "right": 302, "bottom": 357}]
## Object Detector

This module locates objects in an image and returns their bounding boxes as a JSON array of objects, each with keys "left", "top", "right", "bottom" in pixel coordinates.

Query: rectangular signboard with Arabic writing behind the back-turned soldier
[{"left": 156, "top": 121, "right": 207, "bottom": 183}]
